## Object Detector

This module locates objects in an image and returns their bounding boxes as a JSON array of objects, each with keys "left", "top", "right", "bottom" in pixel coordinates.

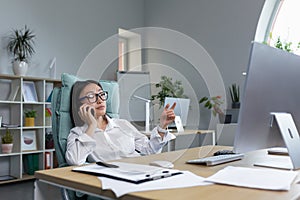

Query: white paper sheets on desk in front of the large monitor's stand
[{"left": 206, "top": 166, "right": 298, "bottom": 190}]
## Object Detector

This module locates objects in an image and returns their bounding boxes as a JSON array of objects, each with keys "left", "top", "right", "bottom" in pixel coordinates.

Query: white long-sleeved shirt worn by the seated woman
[{"left": 65, "top": 116, "right": 175, "bottom": 165}]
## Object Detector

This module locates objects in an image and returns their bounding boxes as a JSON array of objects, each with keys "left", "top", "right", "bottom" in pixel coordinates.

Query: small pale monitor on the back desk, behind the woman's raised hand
[{"left": 164, "top": 97, "right": 190, "bottom": 128}]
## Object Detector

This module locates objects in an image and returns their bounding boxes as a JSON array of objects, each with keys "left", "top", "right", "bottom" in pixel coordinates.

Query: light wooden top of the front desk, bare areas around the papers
[{"left": 35, "top": 146, "right": 300, "bottom": 200}]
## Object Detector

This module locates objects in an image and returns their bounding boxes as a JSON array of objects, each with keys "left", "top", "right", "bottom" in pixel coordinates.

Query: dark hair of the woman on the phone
[{"left": 71, "top": 80, "right": 103, "bottom": 126}]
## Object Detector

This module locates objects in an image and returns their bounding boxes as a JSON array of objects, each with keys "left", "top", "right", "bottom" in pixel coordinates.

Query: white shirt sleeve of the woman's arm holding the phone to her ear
[{"left": 65, "top": 127, "right": 96, "bottom": 165}]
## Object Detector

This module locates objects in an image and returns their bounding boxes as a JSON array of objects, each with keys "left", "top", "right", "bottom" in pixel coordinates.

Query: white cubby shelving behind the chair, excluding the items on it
[{"left": 0, "top": 75, "right": 61, "bottom": 184}]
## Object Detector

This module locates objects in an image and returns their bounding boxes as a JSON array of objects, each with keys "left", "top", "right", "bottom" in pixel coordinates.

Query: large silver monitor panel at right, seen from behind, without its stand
[{"left": 234, "top": 42, "right": 300, "bottom": 153}]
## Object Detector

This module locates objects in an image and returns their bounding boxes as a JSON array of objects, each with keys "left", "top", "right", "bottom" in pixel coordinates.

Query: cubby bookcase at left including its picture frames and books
[{"left": 0, "top": 75, "right": 61, "bottom": 184}]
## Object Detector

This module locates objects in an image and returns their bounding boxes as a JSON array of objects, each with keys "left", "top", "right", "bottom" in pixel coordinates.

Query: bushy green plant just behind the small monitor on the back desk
[{"left": 151, "top": 76, "right": 188, "bottom": 107}]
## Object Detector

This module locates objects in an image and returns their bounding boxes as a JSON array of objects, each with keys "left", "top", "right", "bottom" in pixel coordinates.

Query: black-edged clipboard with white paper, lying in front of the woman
[{"left": 72, "top": 162, "right": 182, "bottom": 184}]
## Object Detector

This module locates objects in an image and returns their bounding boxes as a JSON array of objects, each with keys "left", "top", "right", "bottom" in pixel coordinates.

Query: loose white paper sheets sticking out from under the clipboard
[{"left": 98, "top": 171, "right": 212, "bottom": 197}]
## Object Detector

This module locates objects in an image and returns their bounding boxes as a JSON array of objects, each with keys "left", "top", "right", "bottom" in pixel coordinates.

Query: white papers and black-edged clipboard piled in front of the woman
[{"left": 73, "top": 162, "right": 211, "bottom": 197}]
